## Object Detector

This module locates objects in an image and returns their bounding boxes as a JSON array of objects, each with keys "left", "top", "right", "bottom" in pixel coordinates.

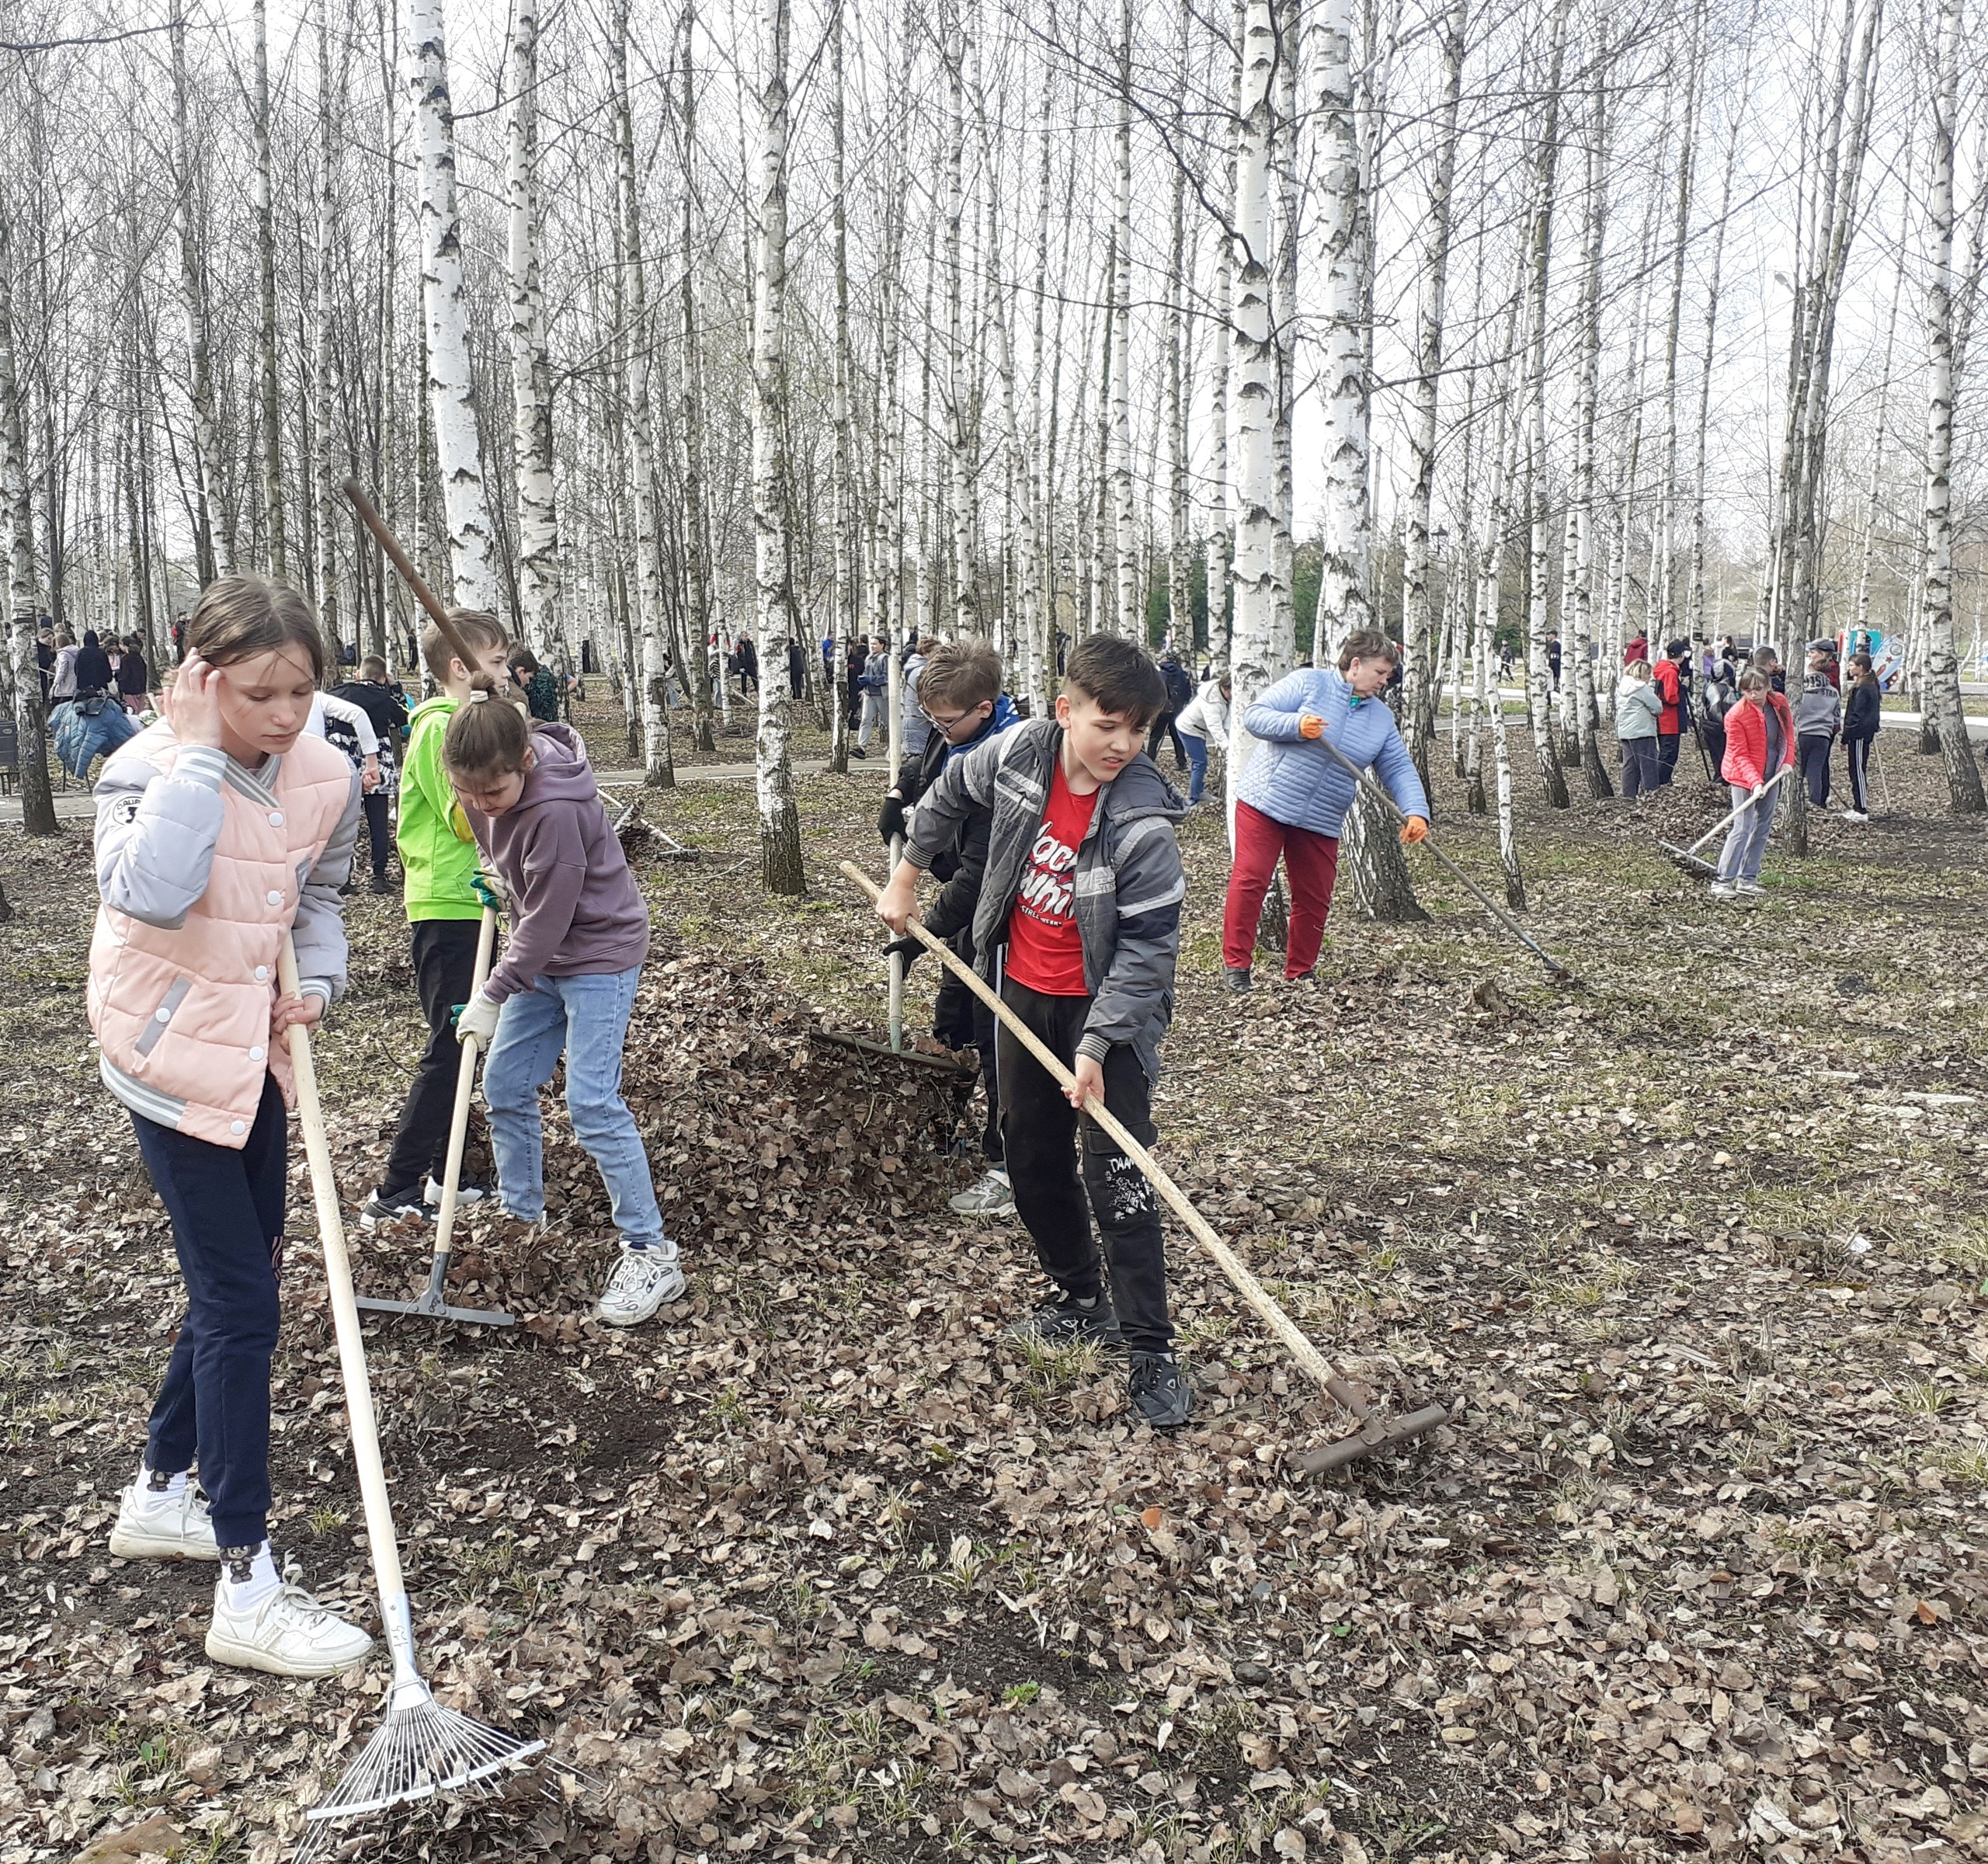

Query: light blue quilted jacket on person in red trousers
[{"left": 1239, "top": 668, "right": 1430, "bottom": 836}]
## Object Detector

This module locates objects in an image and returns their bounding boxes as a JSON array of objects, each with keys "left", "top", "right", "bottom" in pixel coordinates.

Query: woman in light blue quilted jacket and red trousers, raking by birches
[{"left": 1222, "top": 628, "right": 1430, "bottom": 996}]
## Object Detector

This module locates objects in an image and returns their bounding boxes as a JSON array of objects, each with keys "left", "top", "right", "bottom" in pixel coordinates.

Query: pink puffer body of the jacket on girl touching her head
[{"left": 89, "top": 723, "right": 352, "bottom": 1149}]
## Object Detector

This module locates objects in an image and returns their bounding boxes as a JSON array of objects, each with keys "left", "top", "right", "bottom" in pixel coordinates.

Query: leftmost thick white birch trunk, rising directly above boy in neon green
[{"left": 408, "top": 0, "right": 497, "bottom": 614}]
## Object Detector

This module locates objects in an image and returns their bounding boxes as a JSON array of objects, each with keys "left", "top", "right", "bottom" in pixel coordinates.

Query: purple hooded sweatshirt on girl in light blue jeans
[{"left": 463, "top": 725, "right": 648, "bottom": 1003}]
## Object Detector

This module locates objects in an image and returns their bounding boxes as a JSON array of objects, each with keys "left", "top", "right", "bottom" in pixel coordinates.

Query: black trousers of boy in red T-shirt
[{"left": 996, "top": 978, "right": 1173, "bottom": 1353}]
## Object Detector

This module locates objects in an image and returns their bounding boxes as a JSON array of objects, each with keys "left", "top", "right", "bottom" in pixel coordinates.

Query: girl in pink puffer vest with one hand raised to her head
[{"left": 89, "top": 576, "right": 372, "bottom": 1677}]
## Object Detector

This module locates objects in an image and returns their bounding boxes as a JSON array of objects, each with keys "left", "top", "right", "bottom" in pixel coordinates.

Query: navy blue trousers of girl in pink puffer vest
[{"left": 131, "top": 1077, "right": 287, "bottom": 1546}]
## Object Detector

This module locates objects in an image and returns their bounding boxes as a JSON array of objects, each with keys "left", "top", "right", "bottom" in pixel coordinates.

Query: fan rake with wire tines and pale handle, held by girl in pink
[{"left": 276, "top": 932, "right": 544, "bottom": 1860}]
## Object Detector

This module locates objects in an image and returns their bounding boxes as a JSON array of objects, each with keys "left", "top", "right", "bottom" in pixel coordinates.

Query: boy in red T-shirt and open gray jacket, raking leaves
[{"left": 877, "top": 634, "right": 1193, "bottom": 1431}]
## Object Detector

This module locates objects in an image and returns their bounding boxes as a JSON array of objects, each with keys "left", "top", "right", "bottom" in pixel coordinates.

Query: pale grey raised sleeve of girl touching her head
[{"left": 96, "top": 745, "right": 227, "bottom": 932}]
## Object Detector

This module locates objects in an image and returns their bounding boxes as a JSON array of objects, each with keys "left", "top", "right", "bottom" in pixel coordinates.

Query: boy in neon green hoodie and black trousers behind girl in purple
[{"left": 360, "top": 610, "right": 511, "bottom": 1230}]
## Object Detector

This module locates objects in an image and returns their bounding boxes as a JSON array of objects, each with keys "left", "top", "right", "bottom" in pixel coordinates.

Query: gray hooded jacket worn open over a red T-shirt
[{"left": 905, "top": 719, "right": 1187, "bottom": 1079}]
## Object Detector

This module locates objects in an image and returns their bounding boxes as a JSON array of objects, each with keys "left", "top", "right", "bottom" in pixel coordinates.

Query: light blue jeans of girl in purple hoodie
[{"left": 483, "top": 964, "right": 676, "bottom": 1260}]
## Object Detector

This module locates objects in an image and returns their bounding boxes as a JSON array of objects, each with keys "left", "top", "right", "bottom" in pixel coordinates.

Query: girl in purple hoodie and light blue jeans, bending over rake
[{"left": 441, "top": 690, "right": 684, "bottom": 1327}]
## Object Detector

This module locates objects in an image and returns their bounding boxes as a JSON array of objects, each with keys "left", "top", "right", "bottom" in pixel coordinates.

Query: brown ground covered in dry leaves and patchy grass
[{"left": 0, "top": 699, "right": 1988, "bottom": 1864}]
